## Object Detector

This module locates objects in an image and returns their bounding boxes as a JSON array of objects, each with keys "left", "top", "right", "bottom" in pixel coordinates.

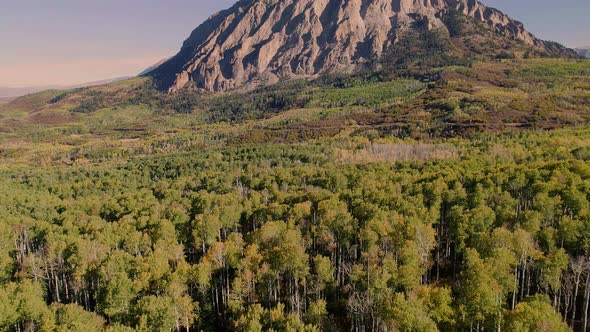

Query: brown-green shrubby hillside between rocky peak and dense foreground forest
[{"left": 0, "top": 59, "right": 590, "bottom": 164}]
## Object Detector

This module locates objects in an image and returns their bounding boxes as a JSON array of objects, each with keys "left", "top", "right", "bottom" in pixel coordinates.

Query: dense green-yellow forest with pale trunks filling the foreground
[{"left": 0, "top": 134, "right": 590, "bottom": 331}]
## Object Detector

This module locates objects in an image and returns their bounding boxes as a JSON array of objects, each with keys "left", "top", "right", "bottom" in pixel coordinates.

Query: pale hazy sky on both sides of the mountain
[{"left": 0, "top": 0, "right": 590, "bottom": 87}]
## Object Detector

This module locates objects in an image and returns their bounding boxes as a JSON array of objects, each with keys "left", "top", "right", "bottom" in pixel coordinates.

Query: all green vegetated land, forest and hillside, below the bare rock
[{"left": 0, "top": 17, "right": 590, "bottom": 332}]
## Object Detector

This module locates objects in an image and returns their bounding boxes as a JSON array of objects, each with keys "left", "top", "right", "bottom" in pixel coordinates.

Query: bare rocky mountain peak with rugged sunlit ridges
[{"left": 149, "top": 0, "right": 577, "bottom": 92}]
